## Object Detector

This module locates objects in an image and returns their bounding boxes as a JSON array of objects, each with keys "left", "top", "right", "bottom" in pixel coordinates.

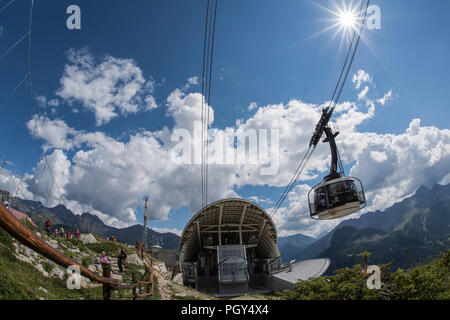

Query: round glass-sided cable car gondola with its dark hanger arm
[{"left": 308, "top": 126, "right": 366, "bottom": 220}]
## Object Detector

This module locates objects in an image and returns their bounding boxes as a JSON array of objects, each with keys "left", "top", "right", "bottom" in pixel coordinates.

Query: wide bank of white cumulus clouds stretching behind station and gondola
[{"left": 0, "top": 65, "right": 450, "bottom": 236}]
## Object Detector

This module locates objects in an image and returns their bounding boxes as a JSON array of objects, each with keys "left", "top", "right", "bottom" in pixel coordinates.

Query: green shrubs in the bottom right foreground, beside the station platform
[{"left": 279, "top": 251, "right": 450, "bottom": 300}]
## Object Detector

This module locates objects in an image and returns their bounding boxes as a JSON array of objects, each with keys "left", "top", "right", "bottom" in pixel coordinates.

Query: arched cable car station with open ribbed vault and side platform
[{"left": 179, "top": 199, "right": 329, "bottom": 296}]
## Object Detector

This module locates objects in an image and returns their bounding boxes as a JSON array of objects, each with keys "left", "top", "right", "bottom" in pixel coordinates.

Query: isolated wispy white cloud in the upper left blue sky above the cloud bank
[{"left": 56, "top": 49, "right": 156, "bottom": 125}]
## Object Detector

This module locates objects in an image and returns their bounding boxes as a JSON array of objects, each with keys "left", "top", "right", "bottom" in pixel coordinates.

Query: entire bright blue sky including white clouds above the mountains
[{"left": 0, "top": 0, "right": 450, "bottom": 236}]
